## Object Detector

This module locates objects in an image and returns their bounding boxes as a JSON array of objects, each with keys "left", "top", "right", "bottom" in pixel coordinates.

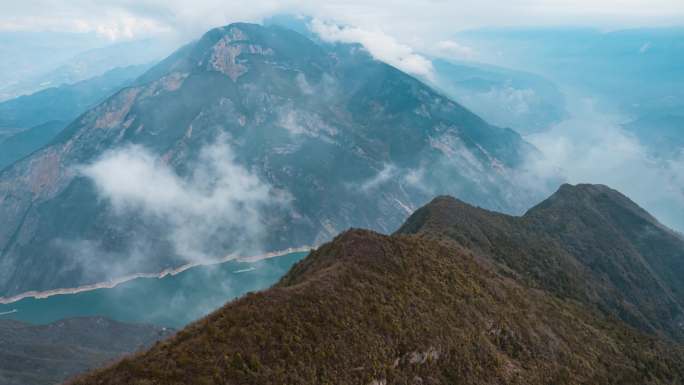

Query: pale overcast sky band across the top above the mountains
[{"left": 0, "top": 0, "right": 684, "bottom": 45}]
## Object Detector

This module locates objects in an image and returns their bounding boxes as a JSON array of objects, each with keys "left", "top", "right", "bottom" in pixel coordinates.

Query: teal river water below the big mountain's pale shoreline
[{"left": 0, "top": 252, "right": 307, "bottom": 328}]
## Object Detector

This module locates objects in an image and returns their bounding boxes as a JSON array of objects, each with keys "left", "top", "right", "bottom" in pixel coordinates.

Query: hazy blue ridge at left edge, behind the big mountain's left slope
[{"left": 0, "top": 65, "right": 149, "bottom": 169}]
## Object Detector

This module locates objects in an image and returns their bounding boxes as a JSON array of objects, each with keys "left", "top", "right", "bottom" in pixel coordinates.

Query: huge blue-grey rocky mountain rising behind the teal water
[{"left": 0, "top": 23, "right": 536, "bottom": 295}]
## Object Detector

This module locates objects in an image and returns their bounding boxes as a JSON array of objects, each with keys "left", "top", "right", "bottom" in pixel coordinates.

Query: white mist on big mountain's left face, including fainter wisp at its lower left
[{"left": 69, "top": 136, "right": 288, "bottom": 277}]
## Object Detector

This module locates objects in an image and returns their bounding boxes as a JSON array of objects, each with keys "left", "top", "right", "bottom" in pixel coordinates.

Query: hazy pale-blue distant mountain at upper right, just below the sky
[{"left": 457, "top": 27, "right": 684, "bottom": 116}]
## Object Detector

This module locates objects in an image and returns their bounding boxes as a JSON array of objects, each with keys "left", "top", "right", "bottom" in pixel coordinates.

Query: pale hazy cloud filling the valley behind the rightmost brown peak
[{"left": 523, "top": 97, "right": 684, "bottom": 231}]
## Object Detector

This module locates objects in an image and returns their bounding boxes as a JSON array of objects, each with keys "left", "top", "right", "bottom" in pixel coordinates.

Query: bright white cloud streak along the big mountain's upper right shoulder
[{"left": 311, "top": 19, "right": 434, "bottom": 80}]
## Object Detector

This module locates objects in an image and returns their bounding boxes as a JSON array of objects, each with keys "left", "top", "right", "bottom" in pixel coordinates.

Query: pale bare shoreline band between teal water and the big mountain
[{"left": 0, "top": 246, "right": 315, "bottom": 305}]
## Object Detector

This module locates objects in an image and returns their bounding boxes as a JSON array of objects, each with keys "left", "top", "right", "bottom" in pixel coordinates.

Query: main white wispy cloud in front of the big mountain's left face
[{"left": 79, "top": 134, "right": 286, "bottom": 262}]
